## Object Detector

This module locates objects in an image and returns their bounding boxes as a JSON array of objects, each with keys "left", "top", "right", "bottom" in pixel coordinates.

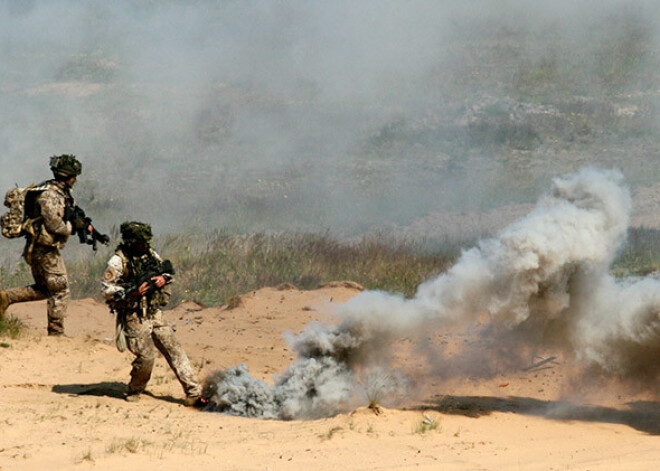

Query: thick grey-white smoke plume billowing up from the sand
[{"left": 207, "top": 168, "right": 660, "bottom": 419}]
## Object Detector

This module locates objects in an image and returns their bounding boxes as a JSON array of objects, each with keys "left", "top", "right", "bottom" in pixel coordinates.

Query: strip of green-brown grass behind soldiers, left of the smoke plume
[{"left": 0, "top": 233, "right": 459, "bottom": 306}]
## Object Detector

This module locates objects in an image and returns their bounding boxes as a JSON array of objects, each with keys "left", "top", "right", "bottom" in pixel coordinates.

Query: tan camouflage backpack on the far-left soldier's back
[{"left": 0, "top": 184, "right": 48, "bottom": 239}]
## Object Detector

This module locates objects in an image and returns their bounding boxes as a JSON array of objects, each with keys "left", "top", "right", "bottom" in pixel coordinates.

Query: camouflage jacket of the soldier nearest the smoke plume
[{"left": 101, "top": 246, "right": 171, "bottom": 316}]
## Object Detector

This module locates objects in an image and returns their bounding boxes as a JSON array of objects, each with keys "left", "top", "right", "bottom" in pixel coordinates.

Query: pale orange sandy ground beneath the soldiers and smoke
[{"left": 0, "top": 286, "right": 660, "bottom": 471}]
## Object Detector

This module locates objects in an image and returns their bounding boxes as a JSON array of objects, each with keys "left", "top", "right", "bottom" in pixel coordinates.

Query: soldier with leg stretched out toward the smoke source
[{"left": 101, "top": 222, "right": 202, "bottom": 407}]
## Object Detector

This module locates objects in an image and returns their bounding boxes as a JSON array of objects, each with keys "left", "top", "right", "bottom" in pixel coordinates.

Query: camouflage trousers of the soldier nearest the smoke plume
[{"left": 125, "top": 311, "right": 202, "bottom": 396}]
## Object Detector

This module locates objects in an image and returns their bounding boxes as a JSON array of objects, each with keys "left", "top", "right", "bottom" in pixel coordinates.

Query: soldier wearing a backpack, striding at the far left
[{"left": 0, "top": 154, "right": 86, "bottom": 336}]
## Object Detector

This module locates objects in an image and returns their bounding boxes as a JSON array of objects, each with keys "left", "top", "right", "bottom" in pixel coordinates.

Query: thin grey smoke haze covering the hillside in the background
[{"left": 0, "top": 0, "right": 658, "bottom": 235}]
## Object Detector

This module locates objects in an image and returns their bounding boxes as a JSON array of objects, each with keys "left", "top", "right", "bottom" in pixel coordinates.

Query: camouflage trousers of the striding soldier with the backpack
[{"left": 7, "top": 245, "right": 70, "bottom": 335}]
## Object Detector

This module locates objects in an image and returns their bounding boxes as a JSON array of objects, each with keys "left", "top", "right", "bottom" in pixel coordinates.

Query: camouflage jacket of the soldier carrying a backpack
[{"left": 27, "top": 180, "right": 75, "bottom": 249}]
